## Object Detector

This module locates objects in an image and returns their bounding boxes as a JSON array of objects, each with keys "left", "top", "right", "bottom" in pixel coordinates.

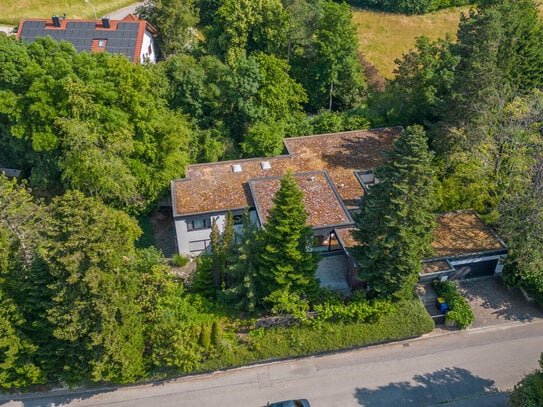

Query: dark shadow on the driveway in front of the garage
[{"left": 458, "top": 277, "right": 543, "bottom": 322}]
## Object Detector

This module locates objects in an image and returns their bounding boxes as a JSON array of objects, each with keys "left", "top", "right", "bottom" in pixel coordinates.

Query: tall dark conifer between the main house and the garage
[{"left": 353, "top": 126, "right": 436, "bottom": 299}]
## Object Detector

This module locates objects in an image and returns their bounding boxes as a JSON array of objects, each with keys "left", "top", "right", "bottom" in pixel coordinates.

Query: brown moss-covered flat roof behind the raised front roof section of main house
[{"left": 172, "top": 127, "right": 402, "bottom": 216}]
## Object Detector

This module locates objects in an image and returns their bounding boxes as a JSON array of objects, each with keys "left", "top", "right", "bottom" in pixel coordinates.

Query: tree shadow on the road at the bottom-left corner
[{"left": 0, "top": 387, "right": 117, "bottom": 407}]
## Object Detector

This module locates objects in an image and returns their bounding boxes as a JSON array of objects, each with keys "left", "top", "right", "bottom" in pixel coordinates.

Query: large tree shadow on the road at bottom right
[{"left": 354, "top": 367, "right": 505, "bottom": 407}]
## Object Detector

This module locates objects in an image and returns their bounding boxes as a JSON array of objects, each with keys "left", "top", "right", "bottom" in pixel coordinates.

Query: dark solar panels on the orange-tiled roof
[{"left": 21, "top": 21, "right": 139, "bottom": 61}]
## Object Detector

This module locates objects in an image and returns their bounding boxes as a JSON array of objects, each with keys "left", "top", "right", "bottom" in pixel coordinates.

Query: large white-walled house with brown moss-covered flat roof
[{"left": 172, "top": 127, "right": 402, "bottom": 255}]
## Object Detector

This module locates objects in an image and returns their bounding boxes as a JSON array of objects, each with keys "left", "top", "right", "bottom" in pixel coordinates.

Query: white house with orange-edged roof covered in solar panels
[{"left": 17, "top": 14, "right": 158, "bottom": 64}]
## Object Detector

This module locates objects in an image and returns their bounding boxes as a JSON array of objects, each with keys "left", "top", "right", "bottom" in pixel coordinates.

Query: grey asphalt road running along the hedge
[{"left": 4, "top": 322, "right": 543, "bottom": 407}]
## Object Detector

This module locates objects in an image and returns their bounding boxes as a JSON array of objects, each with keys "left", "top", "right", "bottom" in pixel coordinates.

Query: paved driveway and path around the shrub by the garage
[{"left": 417, "top": 276, "right": 543, "bottom": 330}]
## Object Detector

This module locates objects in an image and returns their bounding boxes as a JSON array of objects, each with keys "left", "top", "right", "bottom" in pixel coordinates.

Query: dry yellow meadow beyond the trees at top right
[{"left": 353, "top": 7, "right": 469, "bottom": 78}]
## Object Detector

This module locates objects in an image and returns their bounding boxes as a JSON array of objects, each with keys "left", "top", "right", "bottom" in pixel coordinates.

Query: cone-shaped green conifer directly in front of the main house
[{"left": 258, "top": 171, "right": 318, "bottom": 310}]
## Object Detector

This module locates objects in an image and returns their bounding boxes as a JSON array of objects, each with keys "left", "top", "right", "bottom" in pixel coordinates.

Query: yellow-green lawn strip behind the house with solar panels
[{"left": 0, "top": 0, "right": 135, "bottom": 25}]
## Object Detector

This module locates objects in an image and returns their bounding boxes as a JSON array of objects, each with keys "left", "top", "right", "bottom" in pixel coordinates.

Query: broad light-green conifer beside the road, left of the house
[{"left": 34, "top": 192, "right": 145, "bottom": 383}]
